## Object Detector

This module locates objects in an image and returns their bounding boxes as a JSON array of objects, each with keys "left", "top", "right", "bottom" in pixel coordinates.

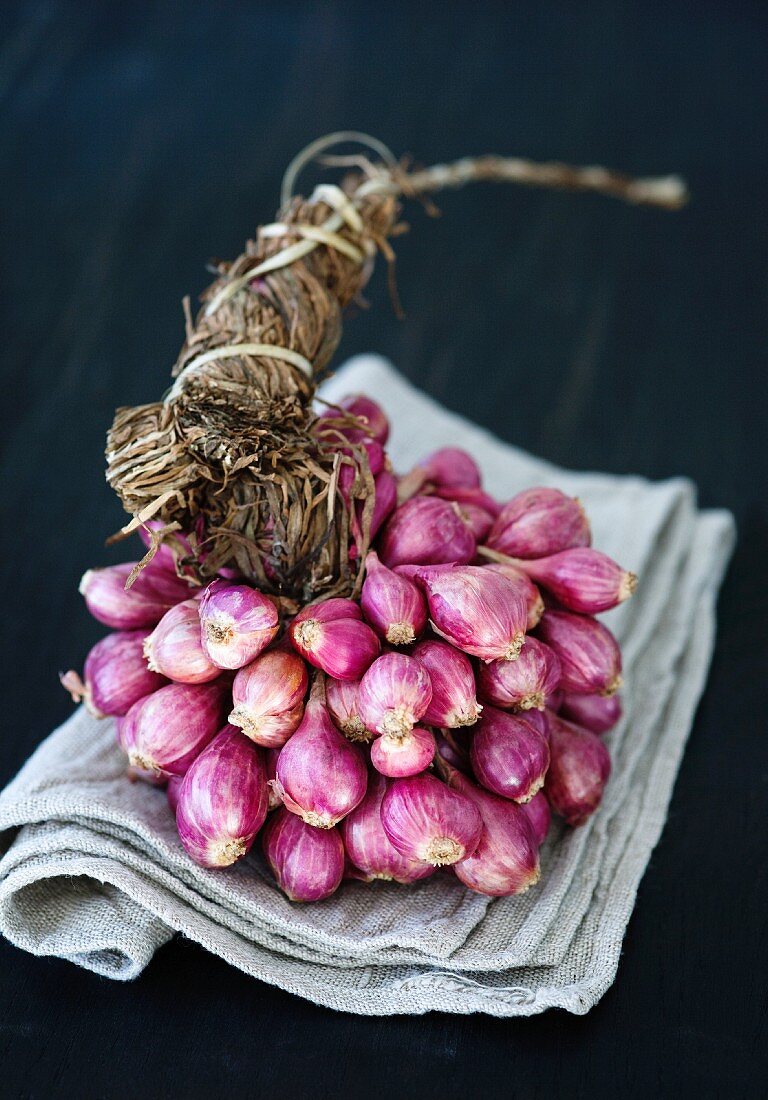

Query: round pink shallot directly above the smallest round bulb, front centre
[{"left": 358, "top": 653, "right": 432, "bottom": 738}]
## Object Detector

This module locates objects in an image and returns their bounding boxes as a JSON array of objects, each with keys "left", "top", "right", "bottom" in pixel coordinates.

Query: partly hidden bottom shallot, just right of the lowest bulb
[{"left": 339, "top": 771, "right": 435, "bottom": 883}]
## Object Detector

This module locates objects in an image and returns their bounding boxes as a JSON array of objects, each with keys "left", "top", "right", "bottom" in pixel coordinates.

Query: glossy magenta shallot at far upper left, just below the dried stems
[{"left": 80, "top": 561, "right": 195, "bottom": 630}]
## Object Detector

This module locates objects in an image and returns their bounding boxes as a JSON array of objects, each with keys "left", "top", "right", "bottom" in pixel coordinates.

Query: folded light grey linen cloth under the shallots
[{"left": 0, "top": 356, "right": 734, "bottom": 1016}]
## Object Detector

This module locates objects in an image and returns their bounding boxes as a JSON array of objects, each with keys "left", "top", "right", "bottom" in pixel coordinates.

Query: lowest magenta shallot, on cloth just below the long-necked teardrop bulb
[{"left": 262, "top": 807, "right": 344, "bottom": 902}]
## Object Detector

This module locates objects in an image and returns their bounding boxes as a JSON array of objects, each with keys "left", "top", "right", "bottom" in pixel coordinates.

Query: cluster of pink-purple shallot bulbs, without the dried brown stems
[{"left": 63, "top": 395, "right": 636, "bottom": 901}]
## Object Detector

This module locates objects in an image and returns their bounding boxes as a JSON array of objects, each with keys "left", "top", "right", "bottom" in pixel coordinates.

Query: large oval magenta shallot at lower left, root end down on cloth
[{"left": 176, "top": 726, "right": 268, "bottom": 867}]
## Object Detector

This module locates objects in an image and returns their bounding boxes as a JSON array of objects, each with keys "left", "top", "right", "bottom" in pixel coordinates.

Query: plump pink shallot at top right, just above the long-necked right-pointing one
[{"left": 487, "top": 488, "right": 592, "bottom": 558}]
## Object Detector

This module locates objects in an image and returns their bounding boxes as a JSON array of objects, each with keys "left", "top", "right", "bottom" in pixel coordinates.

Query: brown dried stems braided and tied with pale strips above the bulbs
[{"left": 107, "top": 134, "right": 684, "bottom": 606}]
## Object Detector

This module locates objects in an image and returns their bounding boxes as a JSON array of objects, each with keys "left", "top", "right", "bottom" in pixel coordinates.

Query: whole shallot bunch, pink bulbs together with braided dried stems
[{"left": 62, "top": 133, "right": 685, "bottom": 901}]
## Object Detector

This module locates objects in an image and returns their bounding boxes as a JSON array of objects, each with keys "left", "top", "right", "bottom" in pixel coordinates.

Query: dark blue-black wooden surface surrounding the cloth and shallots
[{"left": 0, "top": 0, "right": 768, "bottom": 1100}]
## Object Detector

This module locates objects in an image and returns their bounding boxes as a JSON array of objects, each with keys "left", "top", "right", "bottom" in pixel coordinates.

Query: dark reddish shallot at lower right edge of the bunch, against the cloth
[{"left": 545, "top": 714, "right": 611, "bottom": 826}]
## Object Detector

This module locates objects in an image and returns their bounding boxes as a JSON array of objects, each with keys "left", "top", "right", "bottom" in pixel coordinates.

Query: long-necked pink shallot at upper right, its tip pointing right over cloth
[{"left": 508, "top": 547, "right": 637, "bottom": 615}]
